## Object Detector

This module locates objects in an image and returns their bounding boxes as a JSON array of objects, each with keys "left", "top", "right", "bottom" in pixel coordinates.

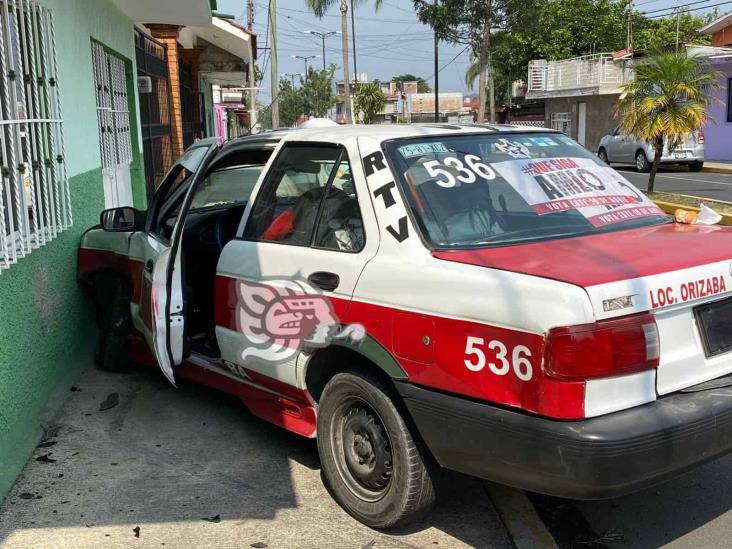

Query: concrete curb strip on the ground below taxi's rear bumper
[{"left": 483, "top": 480, "right": 559, "bottom": 549}]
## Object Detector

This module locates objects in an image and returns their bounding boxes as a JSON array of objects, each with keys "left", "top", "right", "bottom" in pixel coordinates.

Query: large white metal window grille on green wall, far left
[{"left": 0, "top": 0, "right": 72, "bottom": 273}]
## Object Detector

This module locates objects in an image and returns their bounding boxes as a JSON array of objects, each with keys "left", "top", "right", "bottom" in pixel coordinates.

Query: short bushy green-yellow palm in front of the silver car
[{"left": 615, "top": 48, "right": 722, "bottom": 193}]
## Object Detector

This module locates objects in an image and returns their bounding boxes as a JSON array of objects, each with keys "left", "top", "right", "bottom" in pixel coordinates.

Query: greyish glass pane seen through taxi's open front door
[{"left": 191, "top": 164, "right": 264, "bottom": 210}]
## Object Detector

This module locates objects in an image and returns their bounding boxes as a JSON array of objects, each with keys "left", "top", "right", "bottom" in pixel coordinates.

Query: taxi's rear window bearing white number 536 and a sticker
[{"left": 385, "top": 132, "right": 669, "bottom": 248}]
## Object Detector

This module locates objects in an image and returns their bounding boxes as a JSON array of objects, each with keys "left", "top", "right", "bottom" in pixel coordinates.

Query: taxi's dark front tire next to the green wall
[{"left": 94, "top": 280, "right": 132, "bottom": 372}]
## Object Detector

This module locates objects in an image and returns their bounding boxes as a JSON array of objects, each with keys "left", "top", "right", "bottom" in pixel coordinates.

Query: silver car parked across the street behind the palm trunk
[{"left": 597, "top": 128, "right": 704, "bottom": 173}]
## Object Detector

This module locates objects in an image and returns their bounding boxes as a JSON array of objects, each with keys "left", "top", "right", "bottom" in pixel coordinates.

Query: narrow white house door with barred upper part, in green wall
[{"left": 92, "top": 42, "right": 132, "bottom": 208}]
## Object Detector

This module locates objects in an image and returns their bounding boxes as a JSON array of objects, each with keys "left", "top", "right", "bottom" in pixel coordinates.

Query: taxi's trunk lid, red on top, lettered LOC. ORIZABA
[{"left": 434, "top": 220, "right": 732, "bottom": 394}]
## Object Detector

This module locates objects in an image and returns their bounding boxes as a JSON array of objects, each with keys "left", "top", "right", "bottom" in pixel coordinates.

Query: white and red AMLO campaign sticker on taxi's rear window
[{"left": 492, "top": 157, "right": 663, "bottom": 227}]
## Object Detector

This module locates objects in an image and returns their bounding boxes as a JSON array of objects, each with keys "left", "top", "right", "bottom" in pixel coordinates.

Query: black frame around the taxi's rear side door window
[{"left": 242, "top": 141, "right": 368, "bottom": 254}]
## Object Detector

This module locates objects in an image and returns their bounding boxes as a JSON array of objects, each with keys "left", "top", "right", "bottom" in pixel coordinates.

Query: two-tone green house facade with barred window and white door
[{"left": 0, "top": 0, "right": 211, "bottom": 498}]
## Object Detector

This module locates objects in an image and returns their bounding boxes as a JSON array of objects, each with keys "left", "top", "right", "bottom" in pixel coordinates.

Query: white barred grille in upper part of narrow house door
[{"left": 92, "top": 42, "right": 132, "bottom": 168}]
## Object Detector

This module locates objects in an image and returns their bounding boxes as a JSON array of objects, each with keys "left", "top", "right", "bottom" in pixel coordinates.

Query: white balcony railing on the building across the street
[{"left": 529, "top": 53, "right": 630, "bottom": 92}]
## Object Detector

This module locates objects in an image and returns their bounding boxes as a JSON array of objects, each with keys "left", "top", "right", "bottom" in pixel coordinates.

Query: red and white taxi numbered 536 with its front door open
[{"left": 79, "top": 124, "right": 732, "bottom": 527}]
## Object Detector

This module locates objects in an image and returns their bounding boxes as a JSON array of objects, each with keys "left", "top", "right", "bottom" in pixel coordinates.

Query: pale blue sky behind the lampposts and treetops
[{"left": 218, "top": 0, "right": 732, "bottom": 103}]
